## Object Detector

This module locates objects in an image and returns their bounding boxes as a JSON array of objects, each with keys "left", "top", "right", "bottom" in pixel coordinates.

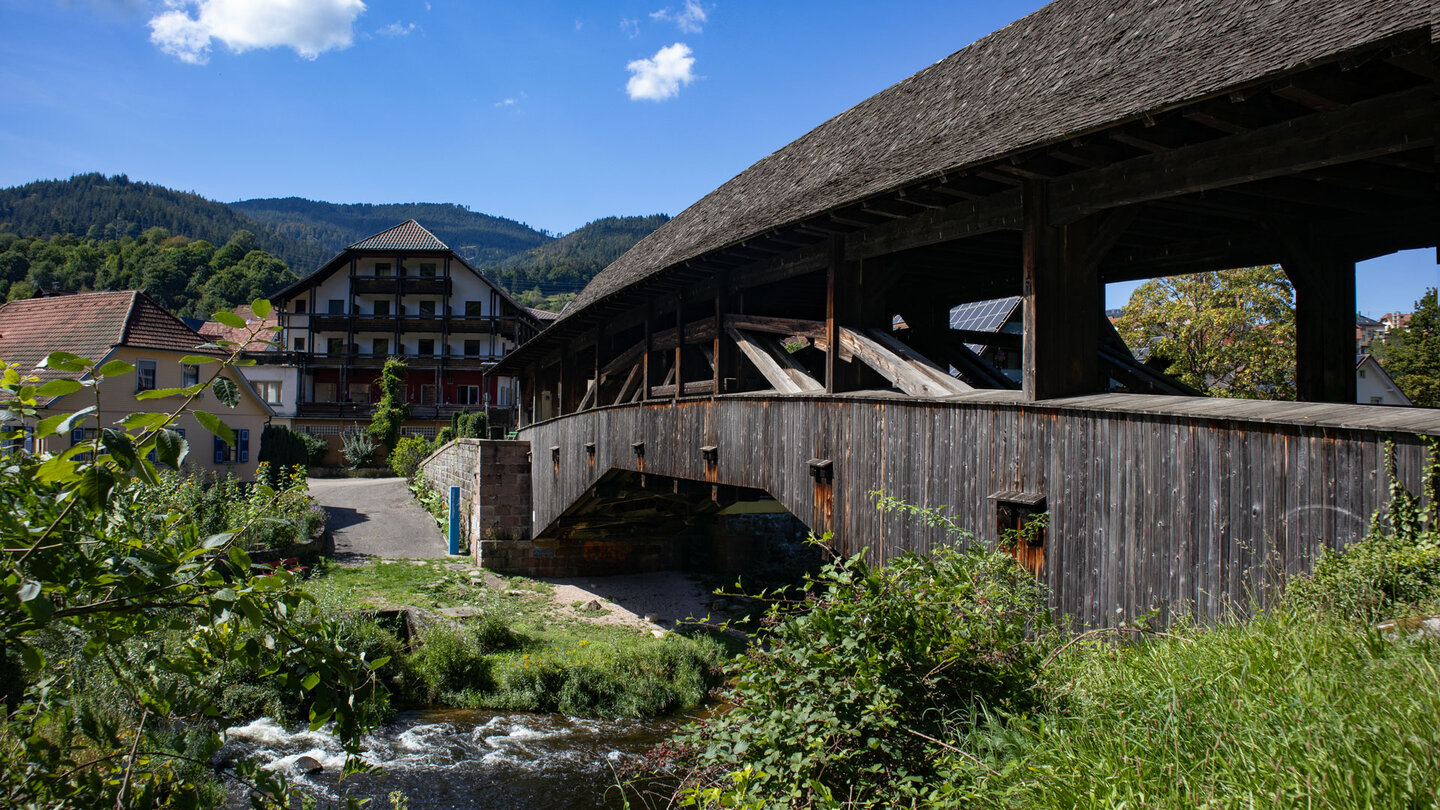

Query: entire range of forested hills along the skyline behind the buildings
[{"left": 0, "top": 173, "right": 670, "bottom": 316}]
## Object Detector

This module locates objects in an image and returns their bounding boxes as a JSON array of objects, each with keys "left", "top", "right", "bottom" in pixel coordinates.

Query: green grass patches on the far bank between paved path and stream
[{"left": 308, "top": 561, "right": 733, "bottom": 716}]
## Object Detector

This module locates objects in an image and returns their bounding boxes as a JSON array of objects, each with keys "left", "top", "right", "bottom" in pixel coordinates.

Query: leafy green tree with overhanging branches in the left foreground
[{"left": 0, "top": 301, "right": 384, "bottom": 810}]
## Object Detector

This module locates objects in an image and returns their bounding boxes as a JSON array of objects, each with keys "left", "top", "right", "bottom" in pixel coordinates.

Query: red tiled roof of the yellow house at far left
[{"left": 0, "top": 290, "right": 204, "bottom": 379}]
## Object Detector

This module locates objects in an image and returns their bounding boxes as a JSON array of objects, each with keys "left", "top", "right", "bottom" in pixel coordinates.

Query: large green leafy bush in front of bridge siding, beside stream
[{"left": 659, "top": 536, "right": 1048, "bottom": 807}]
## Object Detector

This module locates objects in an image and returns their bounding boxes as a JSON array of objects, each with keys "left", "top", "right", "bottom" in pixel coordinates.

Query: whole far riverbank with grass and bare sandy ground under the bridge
[{"left": 307, "top": 559, "right": 742, "bottom": 718}]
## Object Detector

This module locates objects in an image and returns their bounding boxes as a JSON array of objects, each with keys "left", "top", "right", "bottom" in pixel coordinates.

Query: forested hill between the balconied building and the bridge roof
[{"left": 485, "top": 213, "right": 670, "bottom": 311}]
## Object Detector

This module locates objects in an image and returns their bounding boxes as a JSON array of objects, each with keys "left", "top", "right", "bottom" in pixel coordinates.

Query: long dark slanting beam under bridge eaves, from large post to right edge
[{"left": 1050, "top": 88, "right": 1434, "bottom": 223}]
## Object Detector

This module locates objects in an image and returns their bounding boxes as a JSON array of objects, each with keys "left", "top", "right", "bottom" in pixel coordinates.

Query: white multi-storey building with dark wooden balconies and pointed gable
[{"left": 262, "top": 219, "right": 540, "bottom": 450}]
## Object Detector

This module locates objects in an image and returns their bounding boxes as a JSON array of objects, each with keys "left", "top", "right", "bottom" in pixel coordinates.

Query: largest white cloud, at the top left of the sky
[{"left": 150, "top": 0, "right": 364, "bottom": 65}]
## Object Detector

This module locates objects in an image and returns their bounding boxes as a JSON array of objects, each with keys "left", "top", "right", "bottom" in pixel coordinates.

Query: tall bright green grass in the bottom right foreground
[{"left": 937, "top": 608, "right": 1440, "bottom": 809}]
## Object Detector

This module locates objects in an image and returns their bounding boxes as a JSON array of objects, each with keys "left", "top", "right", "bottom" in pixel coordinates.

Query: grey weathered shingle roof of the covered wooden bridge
[{"left": 547, "top": 0, "right": 1440, "bottom": 331}]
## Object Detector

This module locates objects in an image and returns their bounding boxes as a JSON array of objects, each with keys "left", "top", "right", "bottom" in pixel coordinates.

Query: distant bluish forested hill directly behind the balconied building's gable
[{"left": 230, "top": 197, "right": 552, "bottom": 268}]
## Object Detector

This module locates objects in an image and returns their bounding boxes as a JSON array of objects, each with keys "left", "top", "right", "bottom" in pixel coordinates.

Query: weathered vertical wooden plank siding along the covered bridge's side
[{"left": 520, "top": 393, "right": 1440, "bottom": 626}]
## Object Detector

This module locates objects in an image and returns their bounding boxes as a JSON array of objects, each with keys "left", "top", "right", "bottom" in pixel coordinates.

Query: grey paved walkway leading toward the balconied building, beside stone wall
[{"left": 310, "top": 479, "right": 448, "bottom": 565}]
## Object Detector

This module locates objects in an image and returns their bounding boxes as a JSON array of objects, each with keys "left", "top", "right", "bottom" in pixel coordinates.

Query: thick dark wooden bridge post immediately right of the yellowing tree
[{"left": 1274, "top": 225, "right": 1356, "bottom": 402}]
